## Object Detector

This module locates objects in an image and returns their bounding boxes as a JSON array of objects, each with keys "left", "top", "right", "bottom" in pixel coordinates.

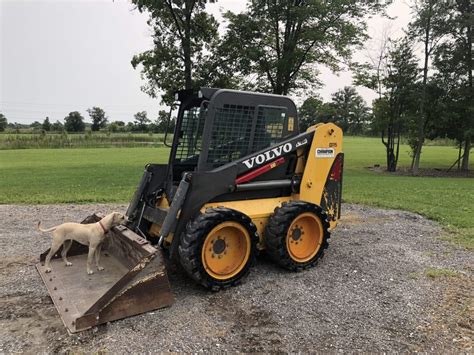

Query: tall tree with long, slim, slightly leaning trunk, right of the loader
[{"left": 408, "top": 0, "right": 448, "bottom": 175}]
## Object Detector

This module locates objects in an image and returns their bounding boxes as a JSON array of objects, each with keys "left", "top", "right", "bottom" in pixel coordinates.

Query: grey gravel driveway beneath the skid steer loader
[{"left": 0, "top": 205, "right": 474, "bottom": 353}]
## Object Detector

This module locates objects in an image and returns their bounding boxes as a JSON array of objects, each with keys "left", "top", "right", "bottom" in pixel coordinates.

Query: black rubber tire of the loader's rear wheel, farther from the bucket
[{"left": 265, "top": 201, "right": 330, "bottom": 271}]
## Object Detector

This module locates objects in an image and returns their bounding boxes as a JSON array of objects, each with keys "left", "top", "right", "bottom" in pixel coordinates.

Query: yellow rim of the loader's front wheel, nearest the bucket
[{"left": 201, "top": 222, "right": 252, "bottom": 280}]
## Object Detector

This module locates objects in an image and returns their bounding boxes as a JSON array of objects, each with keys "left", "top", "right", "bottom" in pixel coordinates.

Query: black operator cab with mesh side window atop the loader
[{"left": 169, "top": 88, "right": 299, "bottom": 182}]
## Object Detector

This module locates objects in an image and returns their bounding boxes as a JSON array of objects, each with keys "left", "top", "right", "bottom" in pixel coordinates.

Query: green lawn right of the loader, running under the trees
[{"left": 343, "top": 137, "right": 474, "bottom": 249}]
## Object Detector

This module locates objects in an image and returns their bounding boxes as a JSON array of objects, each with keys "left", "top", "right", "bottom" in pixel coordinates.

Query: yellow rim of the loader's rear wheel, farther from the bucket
[{"left": 286, "top": 212, "right": 324, "bottom": 263}]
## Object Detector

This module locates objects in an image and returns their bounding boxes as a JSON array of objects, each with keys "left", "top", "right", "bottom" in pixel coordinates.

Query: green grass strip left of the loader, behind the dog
[{"left": 0, "top": 148, "right": 168, "bottom": 203}]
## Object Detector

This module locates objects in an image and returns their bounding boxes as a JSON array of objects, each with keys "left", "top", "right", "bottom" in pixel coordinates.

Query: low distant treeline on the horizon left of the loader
[{"left": 0, "top": 107, "right": 175, "bottom": 133}]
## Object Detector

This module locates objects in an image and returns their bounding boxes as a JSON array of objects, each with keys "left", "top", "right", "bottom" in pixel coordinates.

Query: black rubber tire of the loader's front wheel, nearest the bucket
[{"left": 178, "top": 207, "right": 259, "bottom": 291}]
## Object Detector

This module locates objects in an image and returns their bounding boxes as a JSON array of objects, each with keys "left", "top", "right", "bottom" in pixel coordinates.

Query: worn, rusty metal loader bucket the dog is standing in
[{"left": 36, "top": 215, "right": 174, "bottom": 333}]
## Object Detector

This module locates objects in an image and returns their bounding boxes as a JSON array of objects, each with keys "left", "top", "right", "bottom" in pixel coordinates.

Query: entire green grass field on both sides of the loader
[{"left": 0, "top": 137, "right": 474, "bottom": 248}]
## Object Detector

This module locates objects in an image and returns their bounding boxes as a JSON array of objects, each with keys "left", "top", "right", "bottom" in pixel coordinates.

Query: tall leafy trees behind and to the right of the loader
[{"left": 132, "top": 0, "right": 474, "bottom": 173}]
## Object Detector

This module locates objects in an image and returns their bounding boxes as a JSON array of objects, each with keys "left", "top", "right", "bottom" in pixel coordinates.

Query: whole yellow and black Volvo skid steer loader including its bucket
[{"left": 37, "top": 88, "right": 344, "bottom": 332}]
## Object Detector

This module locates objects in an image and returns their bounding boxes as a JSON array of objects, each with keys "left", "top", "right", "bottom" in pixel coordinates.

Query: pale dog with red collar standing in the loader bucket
[{"left": 38, "top": 212, "right": 125, "bottom": 275}]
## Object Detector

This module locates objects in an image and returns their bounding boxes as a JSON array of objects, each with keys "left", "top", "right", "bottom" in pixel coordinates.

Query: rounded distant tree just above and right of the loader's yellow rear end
[{"left": 331, "top": 86, "right": 370, "bottom": 134}]
